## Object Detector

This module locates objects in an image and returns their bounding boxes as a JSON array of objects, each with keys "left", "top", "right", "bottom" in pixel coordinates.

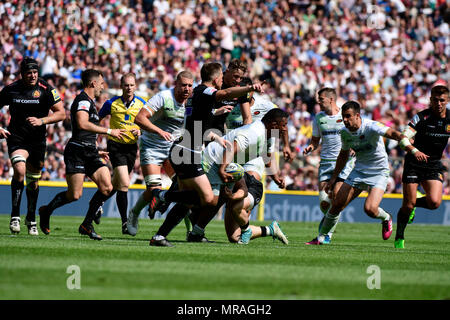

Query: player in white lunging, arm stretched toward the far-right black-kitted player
[{"left": 306, "top": 101, "right": 425, "bottom": 245}]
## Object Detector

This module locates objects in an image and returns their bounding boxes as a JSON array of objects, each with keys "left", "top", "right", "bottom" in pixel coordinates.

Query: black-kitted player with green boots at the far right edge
[{"left": 394, "top": 84, "right": 450, "bottom": 248}]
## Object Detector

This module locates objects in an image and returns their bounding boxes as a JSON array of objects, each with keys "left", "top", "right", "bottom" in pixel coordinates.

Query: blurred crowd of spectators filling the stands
[{"left": 0, "top": 0, "right": 450, "bottom": 194}]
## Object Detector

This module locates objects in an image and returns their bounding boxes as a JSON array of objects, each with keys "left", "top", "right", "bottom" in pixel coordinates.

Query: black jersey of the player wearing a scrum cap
[{"left": 0, "top": 78, "right": 61, "bottom": 141}]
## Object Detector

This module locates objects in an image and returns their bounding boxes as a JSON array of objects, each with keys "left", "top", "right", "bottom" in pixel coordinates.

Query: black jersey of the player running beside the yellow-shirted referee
[{"left": 70, "top": 91, "right": 100, "bottom": 147}]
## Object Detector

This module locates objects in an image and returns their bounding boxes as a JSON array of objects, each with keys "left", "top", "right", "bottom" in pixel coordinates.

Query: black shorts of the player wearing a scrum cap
[{"left": 6, "top": 135, "right": 46, "bottom": 168}]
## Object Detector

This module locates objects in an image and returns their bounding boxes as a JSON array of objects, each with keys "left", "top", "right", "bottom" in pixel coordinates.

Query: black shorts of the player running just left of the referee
[{"left": 64, "top": 141, "right": 106, "bottom": 177}]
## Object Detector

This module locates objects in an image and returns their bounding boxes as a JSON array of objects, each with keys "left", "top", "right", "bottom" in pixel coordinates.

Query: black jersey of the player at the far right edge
[{"left": 405, "top": 108, "right": 450, "bottom": 168}]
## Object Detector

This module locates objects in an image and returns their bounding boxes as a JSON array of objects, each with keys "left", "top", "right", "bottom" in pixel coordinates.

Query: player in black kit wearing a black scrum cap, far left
[{"left": 0, "top": 57, "right": 66, "bottom": 235}]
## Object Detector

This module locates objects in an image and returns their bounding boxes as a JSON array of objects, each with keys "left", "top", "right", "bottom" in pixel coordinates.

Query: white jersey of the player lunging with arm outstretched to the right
[{"left": 341, "top": 118, "right": 389, "bottom": 173}]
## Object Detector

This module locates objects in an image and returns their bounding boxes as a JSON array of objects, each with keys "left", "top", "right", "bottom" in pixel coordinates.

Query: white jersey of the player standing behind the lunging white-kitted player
[{"left": 312, "top": 110, "right": 345, "bottom": 160}]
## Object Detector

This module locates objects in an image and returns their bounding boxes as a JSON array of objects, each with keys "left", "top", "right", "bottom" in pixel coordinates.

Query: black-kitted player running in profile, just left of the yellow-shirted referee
[{"left": 39, "top": 69, "right": 125, "bottom": 240}]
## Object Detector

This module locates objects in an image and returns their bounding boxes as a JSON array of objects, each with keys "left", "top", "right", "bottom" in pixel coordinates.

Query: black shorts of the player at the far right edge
[{"left": 402, "top": 160, "right": 446, "bottom": 183}]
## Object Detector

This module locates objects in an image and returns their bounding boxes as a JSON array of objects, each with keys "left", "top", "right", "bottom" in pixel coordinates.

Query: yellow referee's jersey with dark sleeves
[{"left": 99, "top": 96, "right": 145, "bottom": 144}]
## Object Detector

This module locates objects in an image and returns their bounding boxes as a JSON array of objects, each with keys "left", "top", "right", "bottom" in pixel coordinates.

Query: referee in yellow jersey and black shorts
[{"left": 94, "top": 73, "right": 145, "bottom": 234}]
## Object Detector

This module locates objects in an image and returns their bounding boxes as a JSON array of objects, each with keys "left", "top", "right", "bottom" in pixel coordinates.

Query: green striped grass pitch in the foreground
[{"left": 0, "top": 214, "right": 450, "bottom": 300}]
